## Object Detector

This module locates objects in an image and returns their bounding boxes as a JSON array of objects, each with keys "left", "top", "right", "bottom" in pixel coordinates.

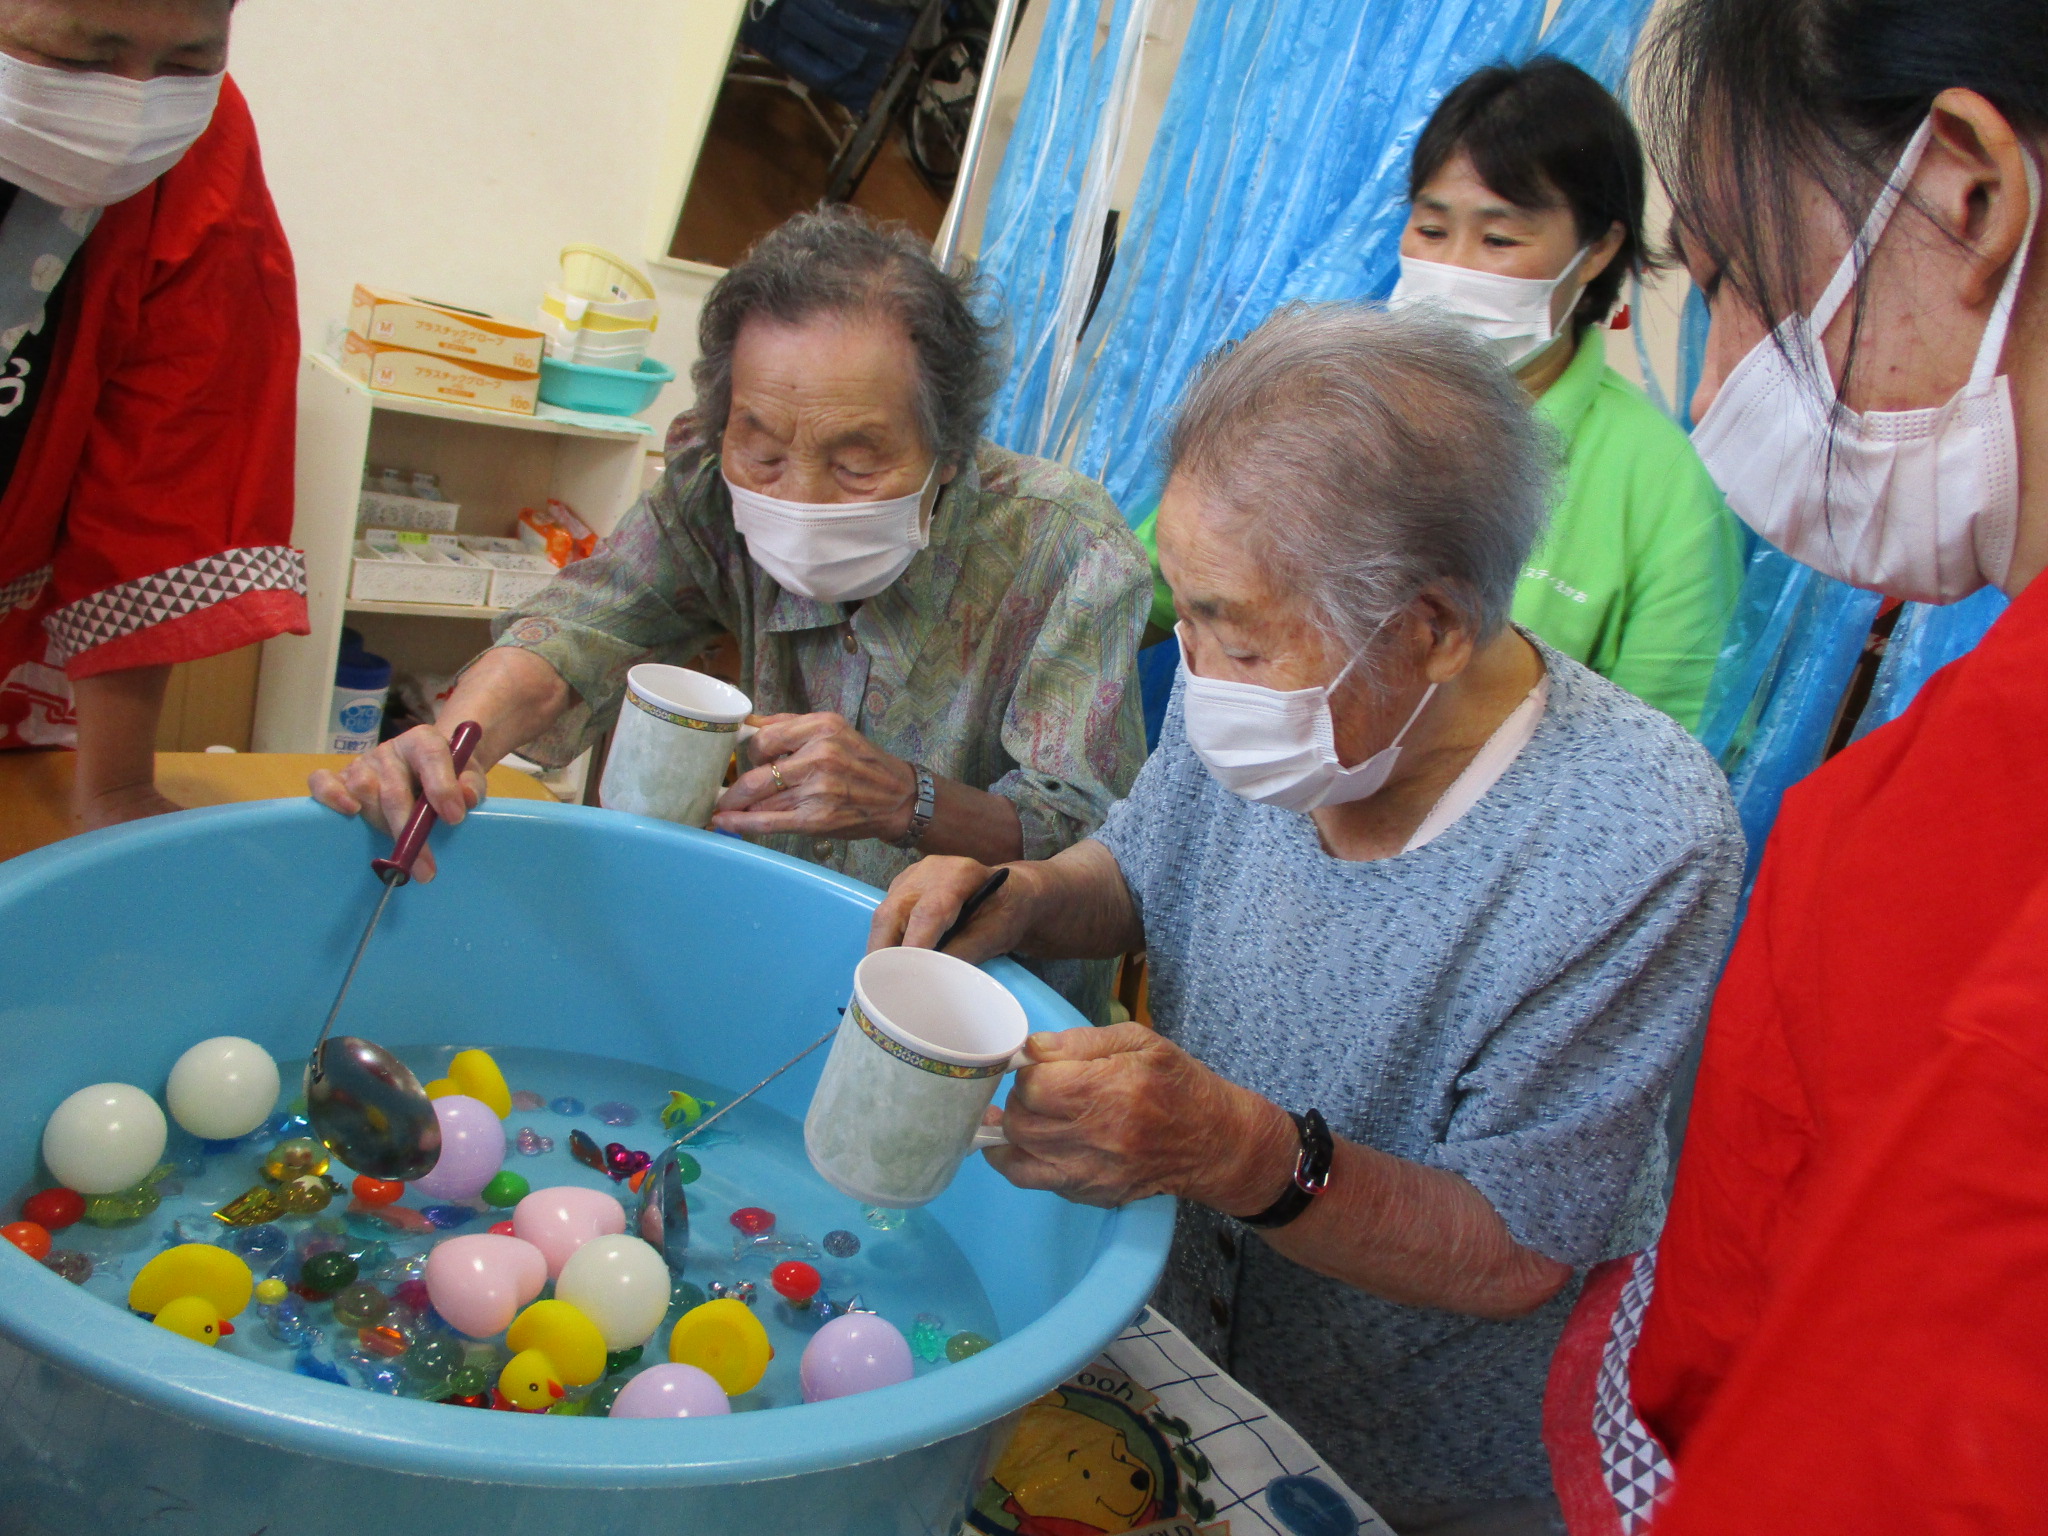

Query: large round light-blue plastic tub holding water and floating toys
[{"left": 0, "top": 801, "right": 1174, "bottom": 1536}]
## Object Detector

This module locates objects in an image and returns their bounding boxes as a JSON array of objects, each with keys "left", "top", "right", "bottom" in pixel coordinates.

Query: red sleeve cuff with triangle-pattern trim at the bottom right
[{"left": 1542, "top": 1247, "right": 1675, "bottom": 1536}]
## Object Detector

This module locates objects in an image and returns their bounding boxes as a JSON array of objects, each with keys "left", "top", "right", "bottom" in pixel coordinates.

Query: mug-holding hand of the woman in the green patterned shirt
[{"left": 711, "top": 715, "right": 918, "bottom": 840}]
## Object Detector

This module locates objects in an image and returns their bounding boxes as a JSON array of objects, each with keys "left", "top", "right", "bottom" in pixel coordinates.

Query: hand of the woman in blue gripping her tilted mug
[{"left": 987, "top": 1024, "right": 1296, "bottom": 1214}]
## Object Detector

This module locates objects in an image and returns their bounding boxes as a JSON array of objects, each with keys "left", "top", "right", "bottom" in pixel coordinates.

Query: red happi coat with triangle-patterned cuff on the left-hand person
[{"left": 0, "top": 80, "right": 307, "bottom": 748}]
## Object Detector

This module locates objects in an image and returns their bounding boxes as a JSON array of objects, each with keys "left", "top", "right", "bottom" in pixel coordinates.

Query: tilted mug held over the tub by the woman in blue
[{"left": 803, "top": 948, "right": 1030, "bottom": 1208}]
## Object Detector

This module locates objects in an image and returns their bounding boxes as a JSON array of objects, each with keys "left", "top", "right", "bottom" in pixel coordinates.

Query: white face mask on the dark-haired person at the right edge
[{"left": 1692, "top": 123, "right": 2040, "bottom": 602}]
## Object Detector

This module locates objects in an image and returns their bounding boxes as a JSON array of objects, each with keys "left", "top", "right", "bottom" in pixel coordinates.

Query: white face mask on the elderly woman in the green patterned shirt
[{"left": 725, "top": 463, "right": 938, "bottom": 602}]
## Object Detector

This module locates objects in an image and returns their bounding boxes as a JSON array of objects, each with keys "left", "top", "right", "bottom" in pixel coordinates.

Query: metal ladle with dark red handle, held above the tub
[{"left": 305, "top": 721, "right": 483, "bottom": 1180}]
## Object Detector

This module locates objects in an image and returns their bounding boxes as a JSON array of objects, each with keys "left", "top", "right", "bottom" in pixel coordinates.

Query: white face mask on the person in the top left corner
[{"left": 0, "top": 53, "right": 221, "bottom": 209}]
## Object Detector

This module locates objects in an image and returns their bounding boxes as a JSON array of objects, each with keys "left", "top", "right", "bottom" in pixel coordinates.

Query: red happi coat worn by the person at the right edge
[{"left": 1546, "top": 582, "right": 2048, "bottom": 1536}]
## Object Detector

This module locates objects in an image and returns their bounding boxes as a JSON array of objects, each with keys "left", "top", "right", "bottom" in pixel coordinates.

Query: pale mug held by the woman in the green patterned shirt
[{"left": 598, "top": 662, "right": 756, "bottom": 827}]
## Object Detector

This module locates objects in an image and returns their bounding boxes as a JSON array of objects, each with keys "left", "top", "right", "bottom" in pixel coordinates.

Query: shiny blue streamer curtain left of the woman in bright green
[{"left": 983, "top": 0, "right": 1649, "bottom": 501}]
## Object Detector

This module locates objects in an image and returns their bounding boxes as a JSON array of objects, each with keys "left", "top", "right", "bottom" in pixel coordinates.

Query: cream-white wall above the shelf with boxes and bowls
[{"left": 229, "top": 0, "right": 743, "bottom": 436}]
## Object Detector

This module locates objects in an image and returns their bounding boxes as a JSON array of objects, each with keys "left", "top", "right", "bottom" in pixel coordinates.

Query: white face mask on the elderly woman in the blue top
[{"left": 1174, "top": 625, "right": 1436, "bottom": 811}]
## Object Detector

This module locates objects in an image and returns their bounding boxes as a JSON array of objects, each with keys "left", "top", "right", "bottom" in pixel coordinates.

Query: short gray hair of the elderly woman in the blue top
[{"left": 1167, "top": 303, "right": 1559, "bottom": 676}]
